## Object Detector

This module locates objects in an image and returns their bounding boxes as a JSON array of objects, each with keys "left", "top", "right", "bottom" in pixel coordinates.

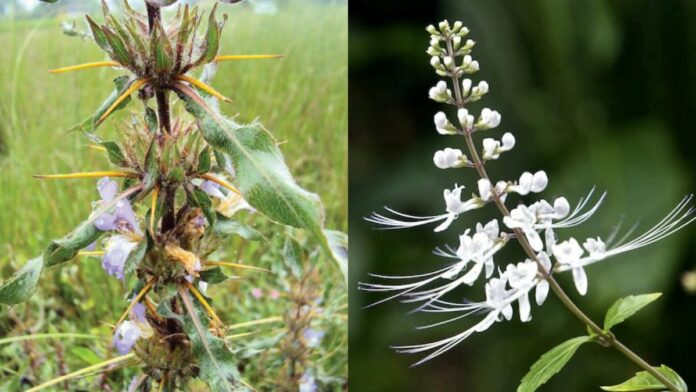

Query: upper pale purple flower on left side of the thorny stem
[{"left": 94, "top": 177, "right": 141, "bottom": 235}]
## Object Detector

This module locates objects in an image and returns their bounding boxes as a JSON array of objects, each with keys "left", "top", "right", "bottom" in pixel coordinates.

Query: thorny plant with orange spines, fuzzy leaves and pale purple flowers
[{"left": 0, "top": 0, "right": 347, "bottom": 391}]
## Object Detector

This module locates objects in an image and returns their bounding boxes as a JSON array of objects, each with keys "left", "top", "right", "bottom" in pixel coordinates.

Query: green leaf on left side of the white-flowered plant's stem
[{"left": 517, "top": 336, "right": 592, "bottom": 392}]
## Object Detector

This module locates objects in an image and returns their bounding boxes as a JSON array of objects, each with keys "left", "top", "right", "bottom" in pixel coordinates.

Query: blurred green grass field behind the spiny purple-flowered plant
[{"left": 0, "top": 3, "right": 347, "bottom": 389}]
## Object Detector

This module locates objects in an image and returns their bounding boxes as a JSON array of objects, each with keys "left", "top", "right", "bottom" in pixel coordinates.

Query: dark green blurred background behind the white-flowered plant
[{"left": 349, "top": 0, "right": 696, "bottom": 392}]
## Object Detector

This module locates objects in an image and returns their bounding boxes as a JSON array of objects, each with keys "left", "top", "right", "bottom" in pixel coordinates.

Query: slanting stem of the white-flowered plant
[{"left": 446, "top": 37, "right": 680, "bottom": 392}]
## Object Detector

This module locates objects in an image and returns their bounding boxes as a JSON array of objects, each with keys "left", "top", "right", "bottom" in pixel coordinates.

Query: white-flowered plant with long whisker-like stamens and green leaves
[{"left": 359, "top": 21, "right": 696, "bottom": 391}]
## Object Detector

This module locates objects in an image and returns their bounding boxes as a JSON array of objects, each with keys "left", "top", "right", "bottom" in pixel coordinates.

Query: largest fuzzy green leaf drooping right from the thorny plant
[{"left": 179, "top": 91, "right": 342, "bottom": 276}]
